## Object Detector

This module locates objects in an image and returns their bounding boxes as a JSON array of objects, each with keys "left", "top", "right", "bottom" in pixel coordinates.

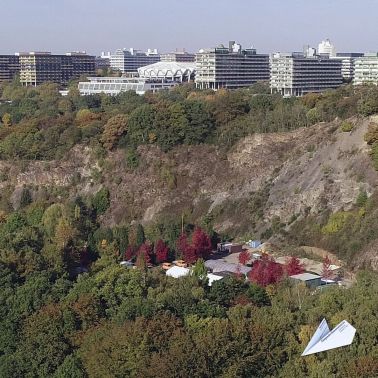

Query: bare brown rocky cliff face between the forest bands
[{"left": 0, "top": 119, "right": 378, "bottom": 264}]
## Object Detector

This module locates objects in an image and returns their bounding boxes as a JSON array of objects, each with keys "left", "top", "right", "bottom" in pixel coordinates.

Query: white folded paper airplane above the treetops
[{"left": 302, "top": 319, "right": 356, "bottom": 356}]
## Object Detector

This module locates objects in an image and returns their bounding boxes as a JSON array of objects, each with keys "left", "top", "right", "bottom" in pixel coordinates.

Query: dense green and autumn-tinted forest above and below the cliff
[{"left": 0, "top": 81, "right": 378, "bottom": 377}]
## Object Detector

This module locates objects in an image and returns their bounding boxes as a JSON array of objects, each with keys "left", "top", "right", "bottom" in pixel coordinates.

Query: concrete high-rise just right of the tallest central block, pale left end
[{"left": 270, "top": 53, "right": 343, "bottom": 96}]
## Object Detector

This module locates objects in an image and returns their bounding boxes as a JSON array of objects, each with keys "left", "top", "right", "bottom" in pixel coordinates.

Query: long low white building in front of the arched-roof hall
[{"left": 78, "top": 77, "right": 178, "bottom": 96}]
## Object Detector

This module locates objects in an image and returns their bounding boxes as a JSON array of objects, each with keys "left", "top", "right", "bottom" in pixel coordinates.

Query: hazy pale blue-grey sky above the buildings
[{"left": 0, "top": 0, "right": 378, "bottom": 54}]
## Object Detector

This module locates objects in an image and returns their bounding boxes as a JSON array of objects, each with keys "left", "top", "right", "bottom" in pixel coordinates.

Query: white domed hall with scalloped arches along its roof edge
[{"left": 138, "top": 62, "right": 196, "bottom": 83}]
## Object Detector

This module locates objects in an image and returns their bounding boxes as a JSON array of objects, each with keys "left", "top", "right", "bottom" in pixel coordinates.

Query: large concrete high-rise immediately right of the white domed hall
[{"left": 195, "top": 41, "right": 269, "bottom": 90}]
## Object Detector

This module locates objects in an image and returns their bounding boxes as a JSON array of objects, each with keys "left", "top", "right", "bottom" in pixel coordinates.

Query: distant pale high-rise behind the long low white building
[{"left": 110, "top": 48, "right": 160, "bottom": 73}]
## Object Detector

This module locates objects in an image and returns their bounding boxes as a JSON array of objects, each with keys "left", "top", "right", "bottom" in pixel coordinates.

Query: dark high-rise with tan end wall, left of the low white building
[{"left": 19, "top": 52, "right": 95, "bottom": 86}]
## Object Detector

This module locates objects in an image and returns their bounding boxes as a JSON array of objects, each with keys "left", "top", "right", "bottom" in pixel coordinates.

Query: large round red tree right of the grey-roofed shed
[{"left": 248, "top": 254, "right": 283, "bottom": 286}]
